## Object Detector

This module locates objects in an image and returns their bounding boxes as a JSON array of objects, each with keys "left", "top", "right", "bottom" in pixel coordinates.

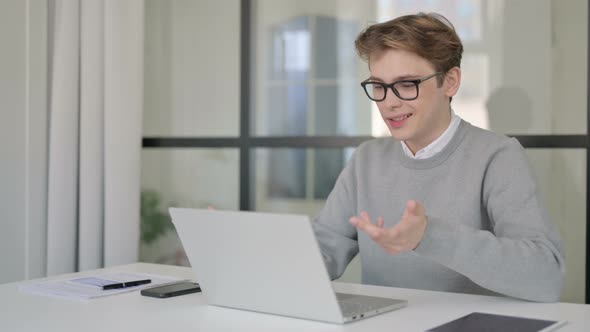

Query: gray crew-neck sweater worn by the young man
[{"left": 313, "top": 121, "right": 565, "bottom": 302}]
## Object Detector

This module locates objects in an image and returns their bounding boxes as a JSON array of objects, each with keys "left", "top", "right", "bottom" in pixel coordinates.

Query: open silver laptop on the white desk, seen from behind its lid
[{"left": 170, "top": 208, "right": 407, "bottom": 324}]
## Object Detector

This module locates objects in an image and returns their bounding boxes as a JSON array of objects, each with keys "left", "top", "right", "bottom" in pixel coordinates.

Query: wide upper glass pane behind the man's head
[{"left": 252, "top": 0, "right": 588, "bottom": 136}]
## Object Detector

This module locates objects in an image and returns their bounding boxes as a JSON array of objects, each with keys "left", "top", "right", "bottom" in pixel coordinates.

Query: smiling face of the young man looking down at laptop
[{"left": 369, "top": 49, "right": 460, "bottom": 153}]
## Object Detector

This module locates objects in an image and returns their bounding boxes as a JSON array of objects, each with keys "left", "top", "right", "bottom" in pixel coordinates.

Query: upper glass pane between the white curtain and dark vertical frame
[{"left": 143, "top": 0, "right": 240, "bottom": 137}]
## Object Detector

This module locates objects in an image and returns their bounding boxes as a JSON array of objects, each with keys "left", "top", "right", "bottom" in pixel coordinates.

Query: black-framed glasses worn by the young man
[{"left": 361, "top": 72, "right": 442, "bottom": 101}]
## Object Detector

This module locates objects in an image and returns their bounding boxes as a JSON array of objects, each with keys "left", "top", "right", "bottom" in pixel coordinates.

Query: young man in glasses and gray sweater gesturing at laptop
[{"left": 314, "top": 14, "right": 565, "bottom": 302}]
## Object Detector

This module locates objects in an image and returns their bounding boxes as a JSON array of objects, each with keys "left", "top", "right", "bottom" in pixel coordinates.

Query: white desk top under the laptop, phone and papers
[{"left": 0, "top": 263, "right": 590, "bottom": 332}]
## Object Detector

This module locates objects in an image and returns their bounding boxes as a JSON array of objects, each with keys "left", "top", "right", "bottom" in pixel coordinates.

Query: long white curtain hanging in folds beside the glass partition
[{"left": 47, "top": 0, "right": 144, "bottom": 275}]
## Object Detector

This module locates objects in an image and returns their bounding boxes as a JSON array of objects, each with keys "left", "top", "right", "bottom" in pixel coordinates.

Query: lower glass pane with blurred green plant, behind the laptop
[{"left": 139, "top": 149, "right": 239, "bottom": 265}]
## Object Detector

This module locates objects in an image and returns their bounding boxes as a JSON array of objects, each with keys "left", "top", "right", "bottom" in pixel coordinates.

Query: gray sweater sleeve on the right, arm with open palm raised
[{"left": 415, "top": 139, "right": 565, "bottom": 302}]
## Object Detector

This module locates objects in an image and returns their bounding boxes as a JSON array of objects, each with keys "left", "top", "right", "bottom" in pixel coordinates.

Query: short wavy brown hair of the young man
[{"left": 354, "top": 13, "right": 463, "bottom": 84}]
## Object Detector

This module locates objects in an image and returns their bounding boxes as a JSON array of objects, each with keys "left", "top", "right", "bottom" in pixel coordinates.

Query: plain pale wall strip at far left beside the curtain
[{"left": 0, "top": 0, "right": 47, "bottom": 283}]
